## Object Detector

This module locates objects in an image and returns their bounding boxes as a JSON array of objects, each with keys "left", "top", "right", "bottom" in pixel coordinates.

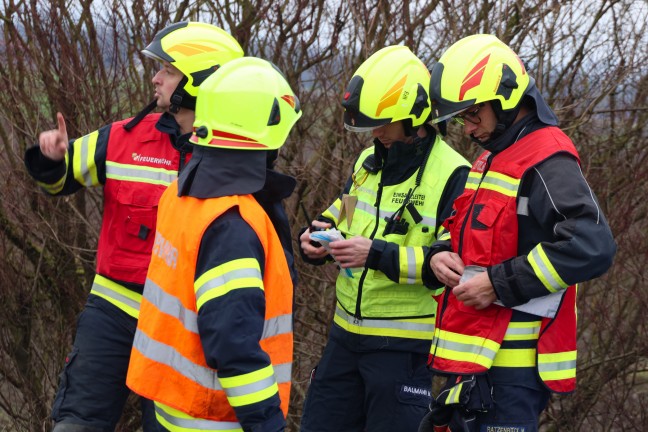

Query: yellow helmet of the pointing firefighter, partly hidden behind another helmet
[{"left": 142, "top": 21, "right": 243, "bottom": 109}]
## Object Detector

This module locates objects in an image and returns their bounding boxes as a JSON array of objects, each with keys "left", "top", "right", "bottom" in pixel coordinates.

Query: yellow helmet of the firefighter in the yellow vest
[{"left": 342, "top": 45, "right": 430, "bottom": 132}]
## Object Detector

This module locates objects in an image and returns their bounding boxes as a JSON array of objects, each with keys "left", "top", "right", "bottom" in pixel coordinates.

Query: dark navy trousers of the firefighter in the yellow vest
[{"left": 301, "top": 329, "right": 432, "bottom": 432}]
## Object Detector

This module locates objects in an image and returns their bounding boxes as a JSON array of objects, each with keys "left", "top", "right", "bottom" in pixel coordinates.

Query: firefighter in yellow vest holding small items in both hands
[{"left": 300, "top": 46, "right": 469, "bottom": 432}]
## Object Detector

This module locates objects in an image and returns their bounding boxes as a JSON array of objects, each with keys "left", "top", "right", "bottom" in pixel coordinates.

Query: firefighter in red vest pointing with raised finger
[{"left": 25, "top": 22, "right": 243, "bottom": 432}]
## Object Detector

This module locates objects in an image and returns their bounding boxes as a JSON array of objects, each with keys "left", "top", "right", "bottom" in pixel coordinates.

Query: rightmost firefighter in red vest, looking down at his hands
[{"left": 419, "top": 34, "right": 616, "bottom": 432}]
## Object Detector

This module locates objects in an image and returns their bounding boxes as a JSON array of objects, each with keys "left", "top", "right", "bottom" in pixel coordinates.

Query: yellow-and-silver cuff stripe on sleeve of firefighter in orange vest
[{"left": 219, "top": 365, "right": 279, "bottom": 407}]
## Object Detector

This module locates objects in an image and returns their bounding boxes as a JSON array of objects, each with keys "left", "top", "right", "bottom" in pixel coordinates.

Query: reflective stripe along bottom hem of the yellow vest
[{"left": 333, "top": 306, "right": 435, "bottom": 340}]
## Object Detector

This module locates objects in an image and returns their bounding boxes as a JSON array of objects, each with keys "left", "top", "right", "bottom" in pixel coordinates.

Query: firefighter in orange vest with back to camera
[{"left": 127, "top": 57, "right": 302, "bottom": 432}]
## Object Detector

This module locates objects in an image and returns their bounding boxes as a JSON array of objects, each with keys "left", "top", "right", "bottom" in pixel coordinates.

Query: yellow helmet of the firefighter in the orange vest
[{"left": 190, "top": 57, "right": 302, "bottom": 150}]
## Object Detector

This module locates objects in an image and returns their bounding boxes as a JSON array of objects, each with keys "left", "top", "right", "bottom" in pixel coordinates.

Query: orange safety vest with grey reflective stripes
[{"left": 127, "top": 181, "right": 293, "bottom": 426}]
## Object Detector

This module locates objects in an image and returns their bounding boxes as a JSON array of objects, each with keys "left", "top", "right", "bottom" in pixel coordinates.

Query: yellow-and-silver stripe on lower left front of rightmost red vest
[{"left": 431, "top": 329, "right": 500, "bottom": 369}]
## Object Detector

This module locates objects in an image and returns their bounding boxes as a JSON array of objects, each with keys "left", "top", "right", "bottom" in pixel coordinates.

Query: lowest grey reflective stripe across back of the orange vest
[{"left": 133, "top": 329, "right": 223, "bottom": 390}]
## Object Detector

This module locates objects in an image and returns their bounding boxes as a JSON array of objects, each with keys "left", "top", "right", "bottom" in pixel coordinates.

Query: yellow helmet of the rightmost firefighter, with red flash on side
[{"left": 430, "top": 34, "right": 534, "bottom": 123}]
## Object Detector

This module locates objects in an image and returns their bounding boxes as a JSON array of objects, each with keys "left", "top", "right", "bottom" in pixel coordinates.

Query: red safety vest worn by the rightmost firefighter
[{"left": 430, "top": 127, "right": 579, "bottom": 393}]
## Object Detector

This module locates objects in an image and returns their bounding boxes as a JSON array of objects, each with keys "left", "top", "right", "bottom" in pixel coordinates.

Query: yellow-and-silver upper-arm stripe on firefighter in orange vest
[{"left": 194, "top": 258, "right": 264, "bottom": 310}]
